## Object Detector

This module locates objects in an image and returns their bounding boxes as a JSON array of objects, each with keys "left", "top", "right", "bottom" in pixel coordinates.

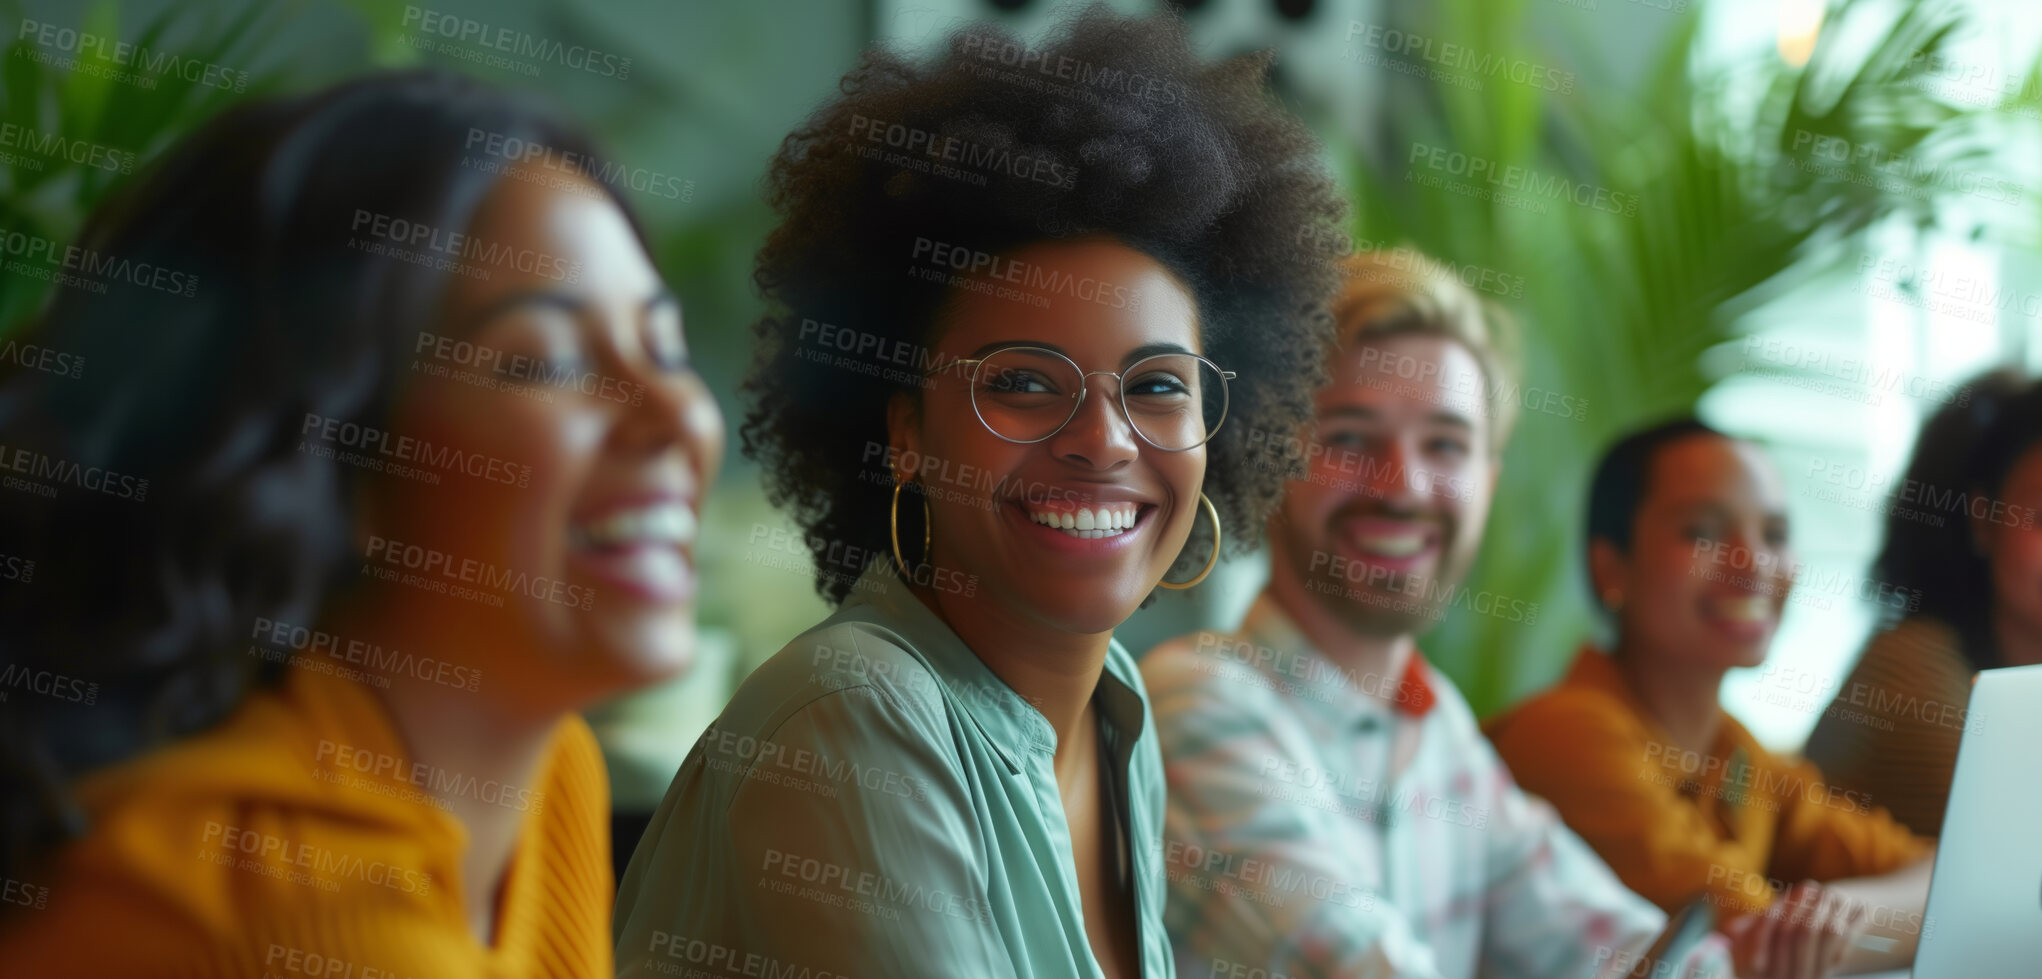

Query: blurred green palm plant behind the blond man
[{"left": 1346, "top": 0, "right": 2025, "bottom": 713}]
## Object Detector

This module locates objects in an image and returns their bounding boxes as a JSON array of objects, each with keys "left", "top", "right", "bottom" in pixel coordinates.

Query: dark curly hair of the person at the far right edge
[{"left": 1873, "top": 368, "right": 2042, "bottom": 670}]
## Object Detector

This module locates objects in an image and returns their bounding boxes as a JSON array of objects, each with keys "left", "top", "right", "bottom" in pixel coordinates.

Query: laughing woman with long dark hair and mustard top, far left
[{"left": 0, "top": 74, "right": 723, "bottom": 977}]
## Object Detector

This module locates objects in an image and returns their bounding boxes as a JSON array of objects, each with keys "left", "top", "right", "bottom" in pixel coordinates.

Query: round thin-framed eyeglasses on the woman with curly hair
[{"left": 950, "top": 345, "right": 1233, "bottom": 452}]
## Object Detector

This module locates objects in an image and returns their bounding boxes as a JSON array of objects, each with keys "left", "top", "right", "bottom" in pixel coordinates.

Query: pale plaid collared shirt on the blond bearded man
[{"left": 1141, "top": 595, "right": 1730, "bottom": 979}]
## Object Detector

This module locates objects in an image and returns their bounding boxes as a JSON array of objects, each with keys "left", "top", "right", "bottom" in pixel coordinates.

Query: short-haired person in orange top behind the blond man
[{"left": 1489, "top": 419, "right": 1934, "bottom": 979}]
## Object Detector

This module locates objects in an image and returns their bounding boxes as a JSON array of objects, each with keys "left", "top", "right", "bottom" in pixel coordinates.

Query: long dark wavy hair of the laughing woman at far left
[{"left": 0, "top": 72, "right": 637, "bottom": 891}]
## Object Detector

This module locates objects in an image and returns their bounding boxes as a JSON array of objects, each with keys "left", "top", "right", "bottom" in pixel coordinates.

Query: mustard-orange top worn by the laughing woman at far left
[{"left": 0, "top": 670, "right": 615, "bottom": 979}]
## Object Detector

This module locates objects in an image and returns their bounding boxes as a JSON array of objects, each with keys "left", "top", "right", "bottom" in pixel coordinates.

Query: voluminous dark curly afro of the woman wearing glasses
[{"left": 741, "top": 6, "right": 1346, "bottom": 603}]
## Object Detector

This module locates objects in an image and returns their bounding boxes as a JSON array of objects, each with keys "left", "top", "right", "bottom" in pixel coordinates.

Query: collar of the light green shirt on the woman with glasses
[{"left": 843, "top": 560, "right": 1148, "bottom": 773}]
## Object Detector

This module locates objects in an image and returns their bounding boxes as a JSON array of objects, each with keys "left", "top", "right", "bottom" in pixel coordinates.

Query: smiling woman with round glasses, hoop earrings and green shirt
[{"left": 617, "top": 6, "right": 1344, "bottom": 979}]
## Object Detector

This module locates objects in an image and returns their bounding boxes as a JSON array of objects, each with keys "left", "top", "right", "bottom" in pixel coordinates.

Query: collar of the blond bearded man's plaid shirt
[{"left": 1229, "top": 591, "right": 1440, "bottom": 724}]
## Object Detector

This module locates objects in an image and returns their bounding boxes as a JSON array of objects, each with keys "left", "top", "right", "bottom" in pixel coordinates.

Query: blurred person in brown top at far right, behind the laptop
[{"left": 1805, "top": 370, "right": 2042, "bottom": 836}]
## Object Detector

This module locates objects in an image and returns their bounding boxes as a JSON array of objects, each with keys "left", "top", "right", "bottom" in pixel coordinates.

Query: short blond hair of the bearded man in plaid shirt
[{"left": 1333, "top": 247, "right": 1523, "bottom": 454}]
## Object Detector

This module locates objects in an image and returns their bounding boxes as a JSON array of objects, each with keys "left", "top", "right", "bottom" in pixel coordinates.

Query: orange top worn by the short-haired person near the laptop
[{"left": 1487, "top": 650, "right": 1932, "bottom": 916}]
